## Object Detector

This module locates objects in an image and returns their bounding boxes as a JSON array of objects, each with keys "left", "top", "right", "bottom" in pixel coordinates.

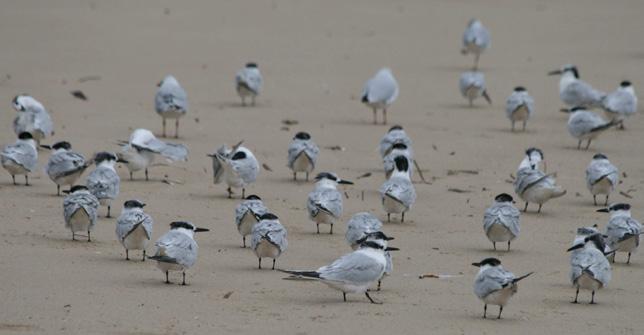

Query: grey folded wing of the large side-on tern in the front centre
[{"left": 317, "top": 251, "right": 385, "bottom": 283}]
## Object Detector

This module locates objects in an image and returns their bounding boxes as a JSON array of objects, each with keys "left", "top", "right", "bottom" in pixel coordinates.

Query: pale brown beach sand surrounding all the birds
[{"left": 0, "top": 0, "right": 644, "bottom": 334}]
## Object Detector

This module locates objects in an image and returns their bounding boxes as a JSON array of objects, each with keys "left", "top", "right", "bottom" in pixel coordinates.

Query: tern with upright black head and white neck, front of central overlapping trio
[{"left": 380, "top": 156, "right": 416, "bottom": 222}]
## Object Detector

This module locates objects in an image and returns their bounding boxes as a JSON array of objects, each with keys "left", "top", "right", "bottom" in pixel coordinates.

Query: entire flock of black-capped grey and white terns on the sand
[{"left": 0, "top": 20, "right": 641, "bottom": 318}]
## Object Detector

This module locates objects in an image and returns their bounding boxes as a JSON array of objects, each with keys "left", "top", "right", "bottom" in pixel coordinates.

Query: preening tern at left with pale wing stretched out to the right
[{"left": 118, "top": 129, "right": 188, "bottom": 181}]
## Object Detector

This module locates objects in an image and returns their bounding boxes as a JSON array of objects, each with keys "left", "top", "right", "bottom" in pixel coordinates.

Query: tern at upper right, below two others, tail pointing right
[{"left": 568, "top": 107, "right": 617, "bottom": 150}]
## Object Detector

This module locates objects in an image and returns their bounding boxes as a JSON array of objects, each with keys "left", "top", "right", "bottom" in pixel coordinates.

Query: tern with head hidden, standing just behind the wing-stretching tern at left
[{"left": 154, "top": 76, "right": 188, "bottom": 138}]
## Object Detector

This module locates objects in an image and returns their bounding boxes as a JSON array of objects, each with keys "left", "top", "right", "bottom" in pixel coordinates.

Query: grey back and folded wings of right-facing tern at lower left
[{"left": 155, "top": 230, "right": 199, "bottom": 267}]
